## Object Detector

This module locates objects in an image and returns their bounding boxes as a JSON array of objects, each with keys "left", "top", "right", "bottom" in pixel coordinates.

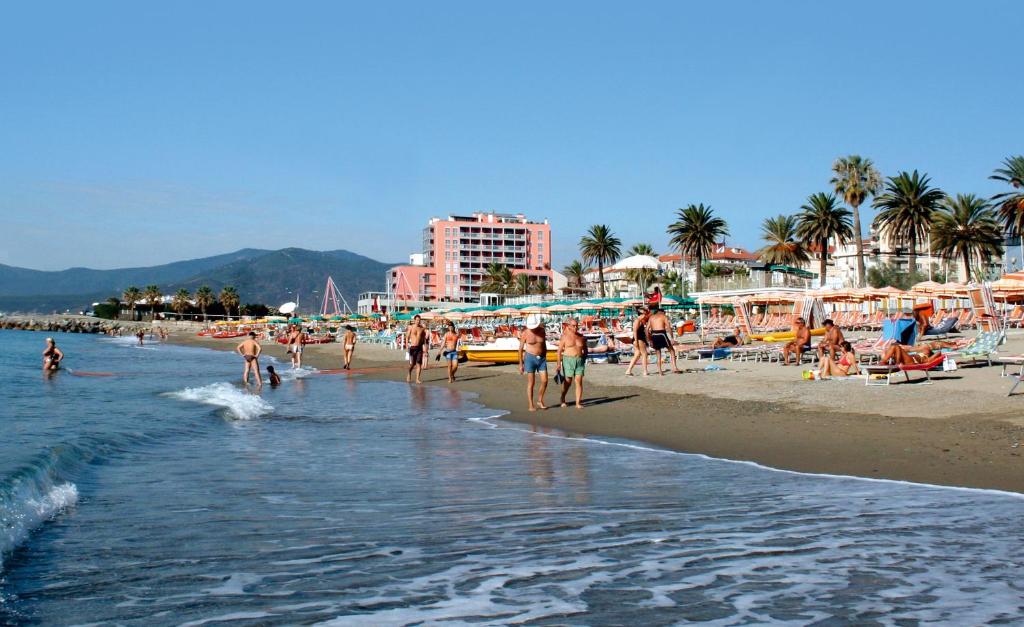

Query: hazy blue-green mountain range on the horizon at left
[{"left": 0, "top": 248, "right": 395, "bottom": 312}]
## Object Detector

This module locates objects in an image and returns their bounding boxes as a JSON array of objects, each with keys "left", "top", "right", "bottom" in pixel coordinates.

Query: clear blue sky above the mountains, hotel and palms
[{"left": 0, "top": 0, "right": 1024, "bottom": 269}]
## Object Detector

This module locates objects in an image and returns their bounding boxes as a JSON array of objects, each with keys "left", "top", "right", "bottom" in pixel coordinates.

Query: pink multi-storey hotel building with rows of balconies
[{"left": 387, "top": 213, "right": 551, "bottom": 302}]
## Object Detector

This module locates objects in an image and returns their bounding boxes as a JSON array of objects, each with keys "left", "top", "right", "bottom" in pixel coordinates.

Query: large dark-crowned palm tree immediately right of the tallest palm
[{"left": 871, "top": 170, "right": 946, "bottom": 275}]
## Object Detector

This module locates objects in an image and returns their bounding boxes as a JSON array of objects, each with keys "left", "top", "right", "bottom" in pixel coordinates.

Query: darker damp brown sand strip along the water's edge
[{"left": 169, "top": 332, "right": 1024, "bottom": 493}]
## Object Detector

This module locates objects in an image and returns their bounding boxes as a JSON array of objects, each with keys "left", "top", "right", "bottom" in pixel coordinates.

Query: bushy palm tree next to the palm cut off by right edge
[{"left": 932, "top": 194, "right": 1002, "bottom": 281}]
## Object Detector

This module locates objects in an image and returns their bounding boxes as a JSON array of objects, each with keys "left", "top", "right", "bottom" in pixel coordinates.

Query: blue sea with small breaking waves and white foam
[{"left": 0, "top": 331, "right": 1024, "bottom": 625}]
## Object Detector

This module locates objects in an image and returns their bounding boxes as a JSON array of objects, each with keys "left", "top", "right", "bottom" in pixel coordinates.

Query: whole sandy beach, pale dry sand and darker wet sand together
[{"left": 172, "top": 332, "right": 1024, "bottom": 493}]
